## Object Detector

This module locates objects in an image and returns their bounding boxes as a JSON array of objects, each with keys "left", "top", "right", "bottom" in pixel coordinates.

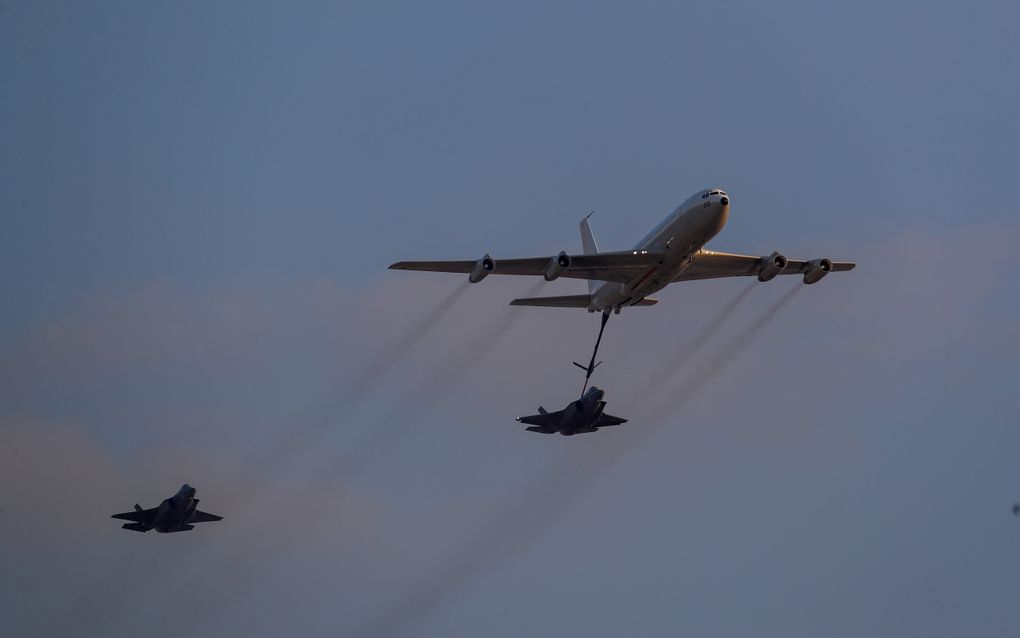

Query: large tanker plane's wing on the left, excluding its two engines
[{"left": 390, "top": 250, "right": 662, "bottom": 283}]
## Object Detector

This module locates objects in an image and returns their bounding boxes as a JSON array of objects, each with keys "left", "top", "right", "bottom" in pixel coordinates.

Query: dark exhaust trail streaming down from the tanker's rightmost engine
[{"left": 351, "top": 286, "right": 801, "bottom": 637}]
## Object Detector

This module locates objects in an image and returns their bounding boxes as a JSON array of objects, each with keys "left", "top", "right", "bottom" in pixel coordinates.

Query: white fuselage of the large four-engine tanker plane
[{"left": 588, "top": 188, "right": 729, "bottom": 312}]
